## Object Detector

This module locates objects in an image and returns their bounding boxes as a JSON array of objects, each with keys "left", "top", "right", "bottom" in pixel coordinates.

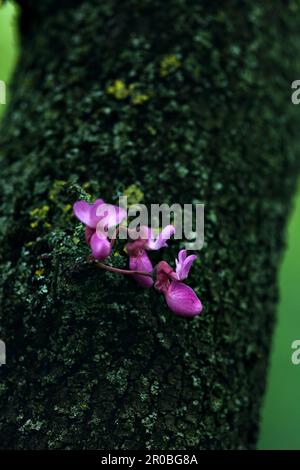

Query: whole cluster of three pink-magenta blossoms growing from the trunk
[{"left": 73, "top": 199, "right": 202, "bottom": 317}]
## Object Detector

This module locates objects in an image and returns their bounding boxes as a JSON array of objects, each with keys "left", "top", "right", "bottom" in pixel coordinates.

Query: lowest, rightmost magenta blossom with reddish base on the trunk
[{"left": 154, "top": 250, "right": 202, "bottom": 317}]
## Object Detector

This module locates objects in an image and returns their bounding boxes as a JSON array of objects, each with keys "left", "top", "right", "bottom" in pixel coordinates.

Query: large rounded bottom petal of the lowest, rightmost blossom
[{"left": 165, "top": 281, "right": 202, "bottom": 317}]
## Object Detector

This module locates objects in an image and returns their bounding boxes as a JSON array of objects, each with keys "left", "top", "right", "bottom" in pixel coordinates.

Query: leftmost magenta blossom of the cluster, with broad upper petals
[{"left": 73, "top": 199, "right": 126, "bottom": 260}]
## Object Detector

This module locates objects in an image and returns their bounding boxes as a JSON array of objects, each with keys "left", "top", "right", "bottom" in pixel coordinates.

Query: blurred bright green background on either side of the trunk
[{"left": 0, "top": 3, "right": 300, "bottom": 449}]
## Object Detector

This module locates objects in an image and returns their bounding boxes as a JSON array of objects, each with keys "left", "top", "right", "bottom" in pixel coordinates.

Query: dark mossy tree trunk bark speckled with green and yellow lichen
[{"left": 0, "top": 0, "right": 299, "bottom": 450}]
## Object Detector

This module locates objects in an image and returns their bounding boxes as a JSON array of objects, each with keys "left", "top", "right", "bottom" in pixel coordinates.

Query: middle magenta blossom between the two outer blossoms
[{"left": 126, "top": 225, "right": 175, "bottom": 288}]
